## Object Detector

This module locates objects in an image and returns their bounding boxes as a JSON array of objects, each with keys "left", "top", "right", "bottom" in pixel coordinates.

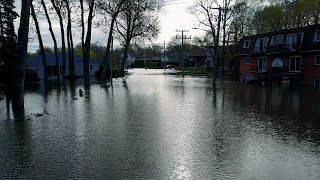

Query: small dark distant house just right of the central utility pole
[{"left": 188, "top": 49, "right": 213, "bottom": 67}]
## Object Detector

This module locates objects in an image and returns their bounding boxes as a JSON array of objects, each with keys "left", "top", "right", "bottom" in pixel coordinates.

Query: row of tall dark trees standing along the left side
[{"left": 0, "top": 0, "right": 163, "bottom": 114}]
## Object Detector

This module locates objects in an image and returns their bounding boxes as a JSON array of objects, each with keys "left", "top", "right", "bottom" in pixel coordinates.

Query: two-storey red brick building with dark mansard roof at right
[{"left": 236, "top": 25, "right": 320, "bottom": 87}]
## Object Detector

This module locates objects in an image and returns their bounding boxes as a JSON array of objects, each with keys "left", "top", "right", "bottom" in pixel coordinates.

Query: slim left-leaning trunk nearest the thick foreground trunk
[{"left": 31, "top": 3, "right": 48, "bottom": 82}]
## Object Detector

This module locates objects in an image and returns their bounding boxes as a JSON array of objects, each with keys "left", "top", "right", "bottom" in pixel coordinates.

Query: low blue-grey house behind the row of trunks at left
[{"left": 26, "top": 54, "right": 100, "bottom": 79}]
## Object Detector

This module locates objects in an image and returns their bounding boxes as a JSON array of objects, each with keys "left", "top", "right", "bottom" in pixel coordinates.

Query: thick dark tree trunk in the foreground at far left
[{"left": 10, "top": 0, "right": 32, "bottom": 112}]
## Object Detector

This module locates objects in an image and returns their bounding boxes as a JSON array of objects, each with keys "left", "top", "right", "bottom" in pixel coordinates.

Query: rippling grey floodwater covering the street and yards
[{"left": 0, "top": 69, "right": 320, "bottom": 180}]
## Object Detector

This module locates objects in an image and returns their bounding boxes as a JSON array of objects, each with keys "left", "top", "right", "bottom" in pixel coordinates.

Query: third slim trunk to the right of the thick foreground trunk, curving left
[{"left": 51, "top": 0, "right": 67, "bottom": 79}]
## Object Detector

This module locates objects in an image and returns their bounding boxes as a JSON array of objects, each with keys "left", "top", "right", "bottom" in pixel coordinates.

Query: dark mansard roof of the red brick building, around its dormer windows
[{"left": 237, "top": 24, "right": 320, "bottom": 55}]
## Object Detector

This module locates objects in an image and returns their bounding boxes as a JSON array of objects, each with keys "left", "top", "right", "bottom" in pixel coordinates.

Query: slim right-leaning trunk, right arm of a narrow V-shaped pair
[{"left": 83, "top": 0, "right": 95, "bottom": 78}]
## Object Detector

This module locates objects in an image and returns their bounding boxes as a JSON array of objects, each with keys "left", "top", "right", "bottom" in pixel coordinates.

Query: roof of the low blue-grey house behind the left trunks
[{"left": 26, "top": 53, "right": 99, "bottom": 65}]
